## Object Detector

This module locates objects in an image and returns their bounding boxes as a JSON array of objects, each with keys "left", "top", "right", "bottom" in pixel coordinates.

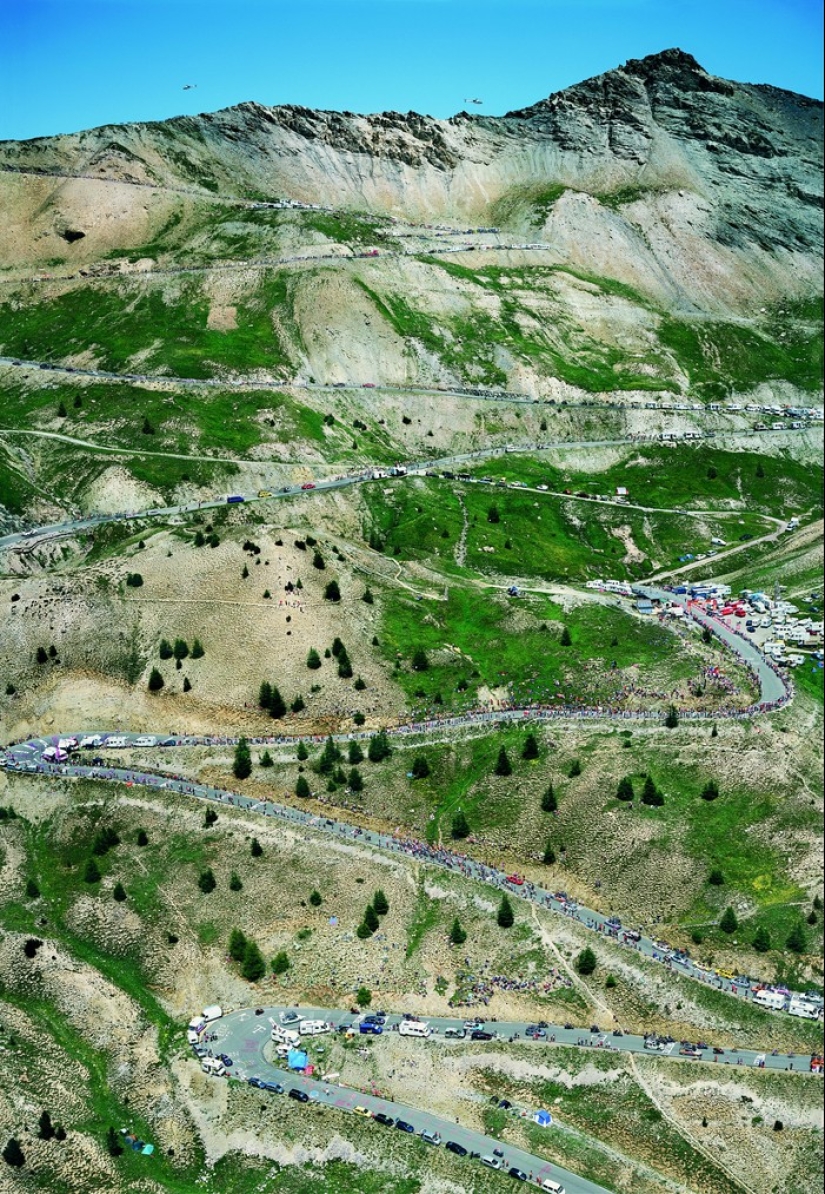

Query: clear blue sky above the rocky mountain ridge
[{"left": 0, "top": 0, "right": 823, "bottom": 139}]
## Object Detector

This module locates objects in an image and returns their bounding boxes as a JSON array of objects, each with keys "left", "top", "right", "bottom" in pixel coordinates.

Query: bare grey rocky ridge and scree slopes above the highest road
[{"left": 0, "top": 50, "right": 823, "bottom": 313}]
